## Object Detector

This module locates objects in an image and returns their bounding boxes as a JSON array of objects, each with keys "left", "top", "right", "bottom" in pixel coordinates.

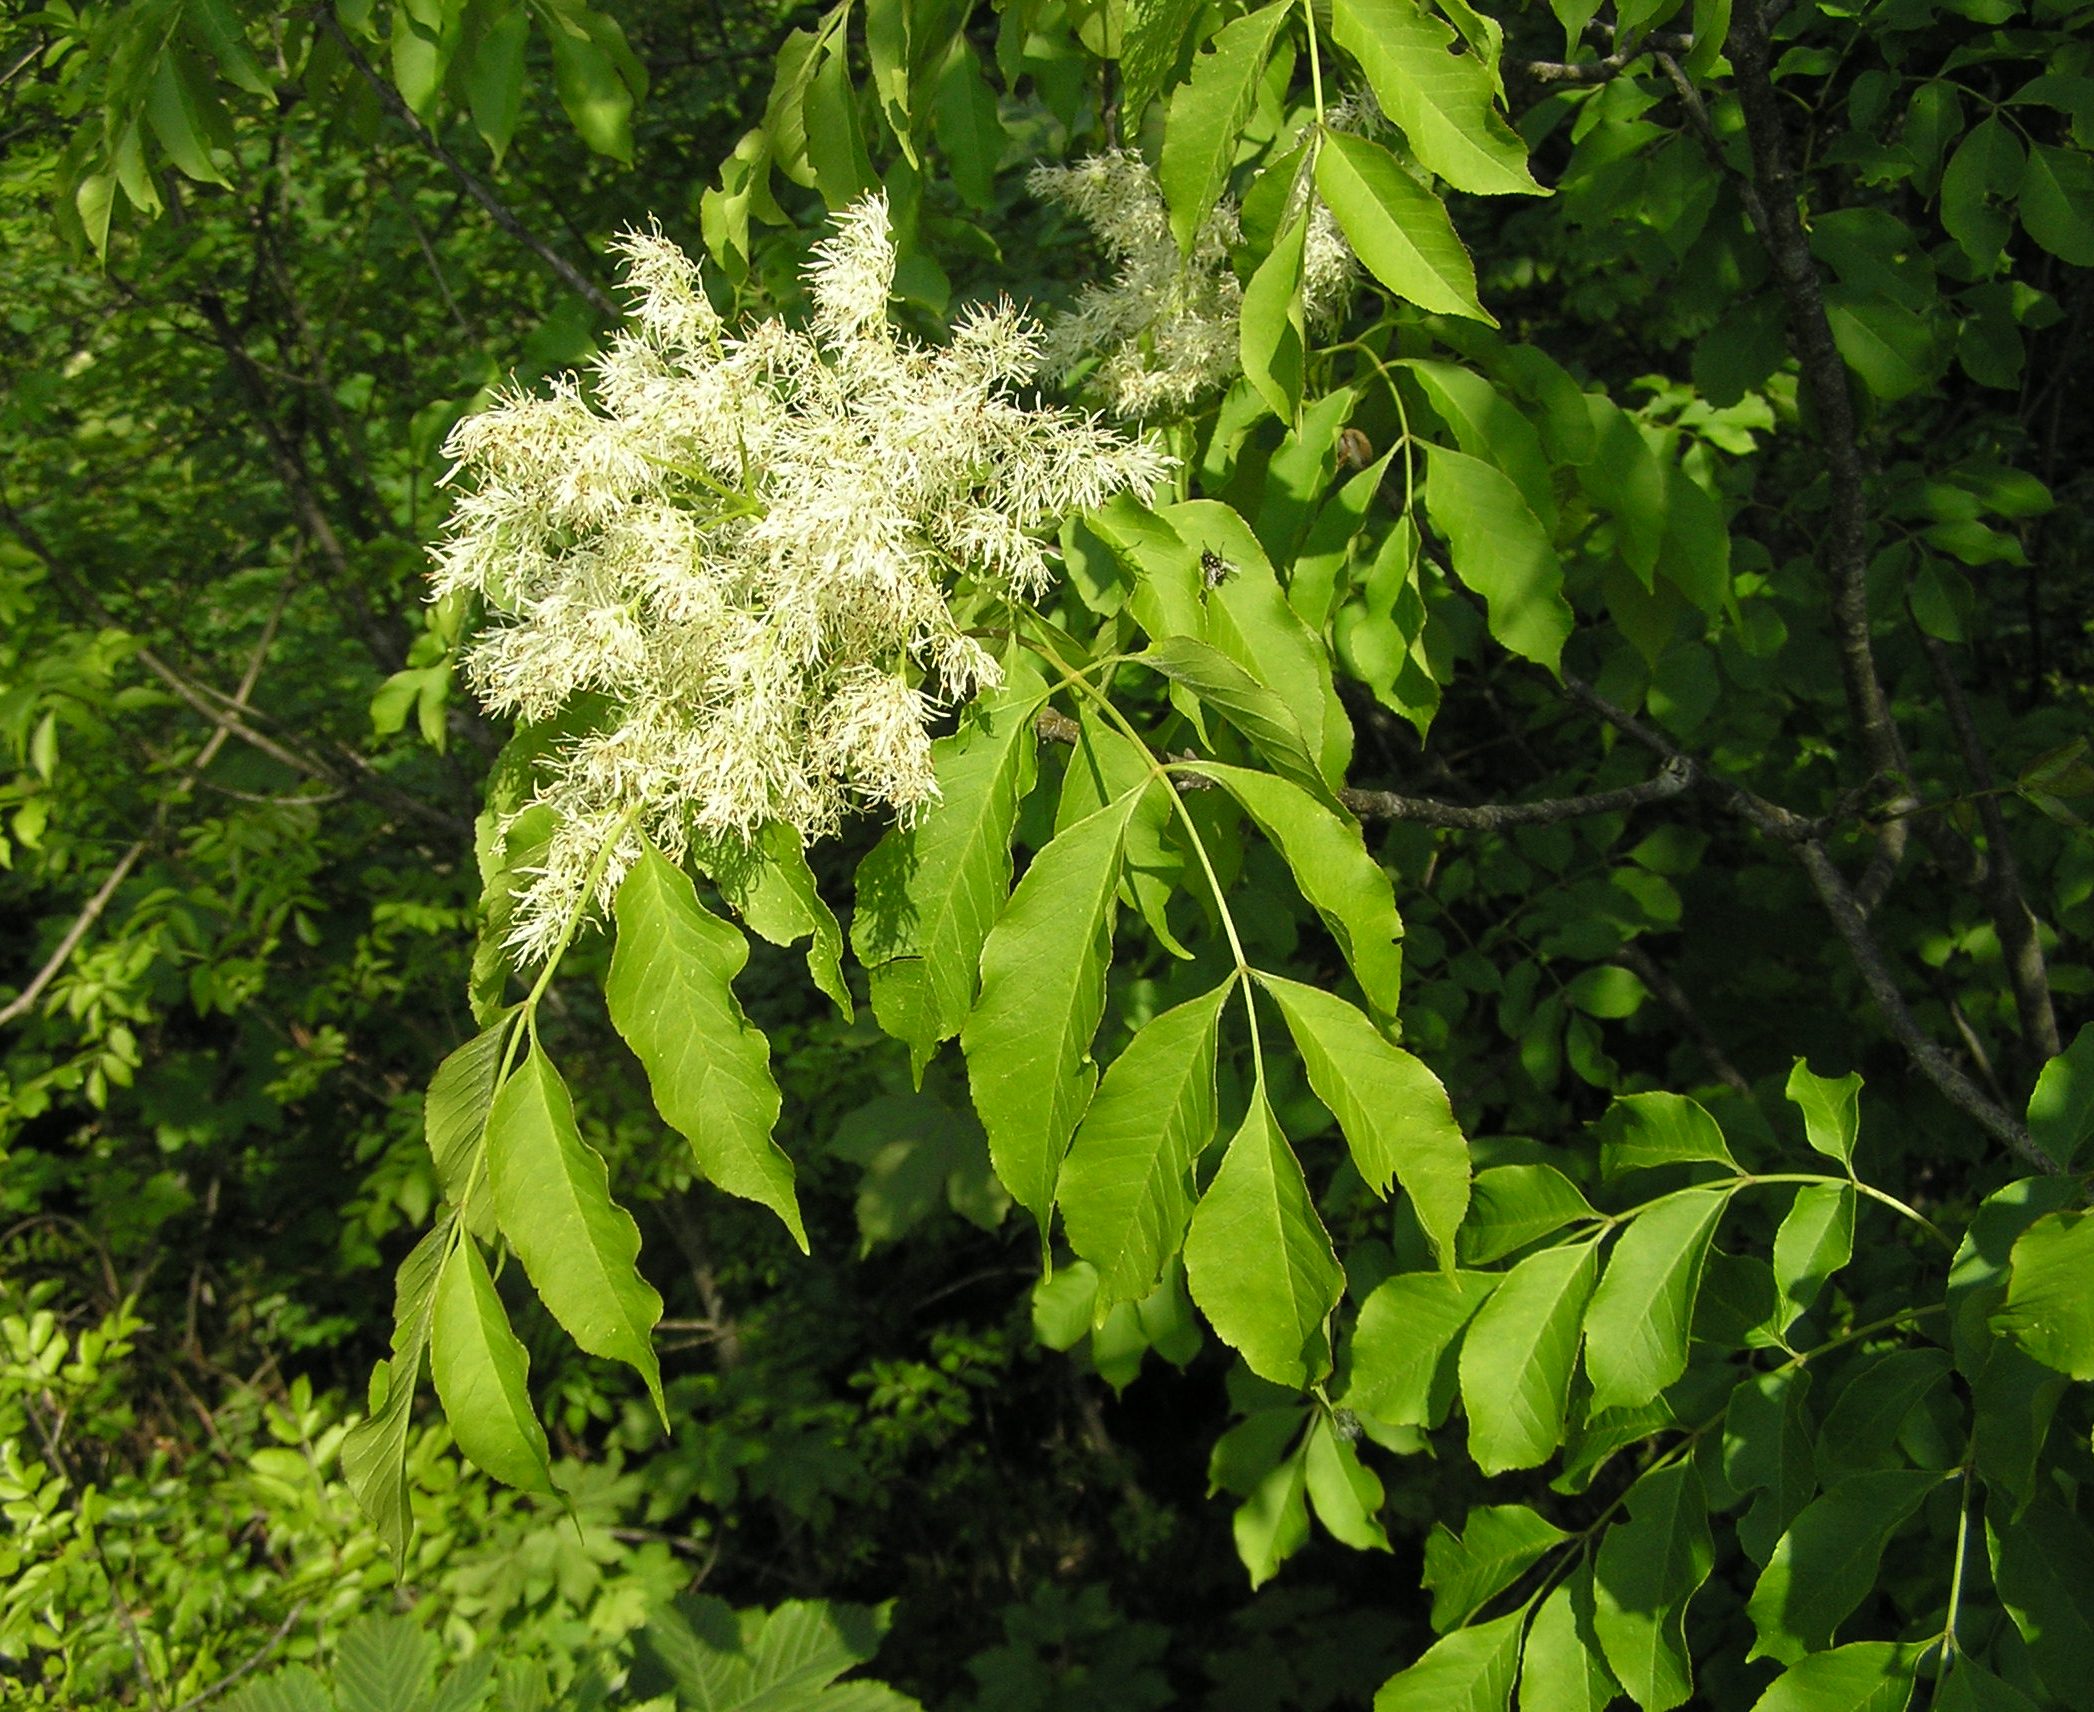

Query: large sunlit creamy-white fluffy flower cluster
[{"left": 433, "top": 195, "right": 1168, "bottom": 961}]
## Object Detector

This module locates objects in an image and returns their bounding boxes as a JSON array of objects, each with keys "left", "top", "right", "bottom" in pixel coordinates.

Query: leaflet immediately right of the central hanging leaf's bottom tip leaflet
[{"left": 1258, "top": 973, "right": 1468, "bottom": 1270}]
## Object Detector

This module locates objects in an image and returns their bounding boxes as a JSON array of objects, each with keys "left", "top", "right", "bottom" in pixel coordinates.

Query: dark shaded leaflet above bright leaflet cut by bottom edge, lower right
[{"left": 1744, "top": 1469, "right": 1947, "bottom": 1664}]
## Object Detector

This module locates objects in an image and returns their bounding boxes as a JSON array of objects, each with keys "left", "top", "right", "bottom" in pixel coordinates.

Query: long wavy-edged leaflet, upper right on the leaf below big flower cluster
[{"left": 603, "top": 848, "right": 806, "bottom": 1254}]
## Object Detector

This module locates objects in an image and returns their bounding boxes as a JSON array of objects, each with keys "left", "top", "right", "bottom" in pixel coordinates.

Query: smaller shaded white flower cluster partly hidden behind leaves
[{"left": 1028, "top": 149, "right": 1353, "bottom": 416}]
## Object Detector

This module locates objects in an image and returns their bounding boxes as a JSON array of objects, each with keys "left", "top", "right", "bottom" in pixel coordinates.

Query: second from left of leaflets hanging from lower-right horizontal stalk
[{"left": 1462, "top": 1243, "right": 1598, "bottom": 1473}]
